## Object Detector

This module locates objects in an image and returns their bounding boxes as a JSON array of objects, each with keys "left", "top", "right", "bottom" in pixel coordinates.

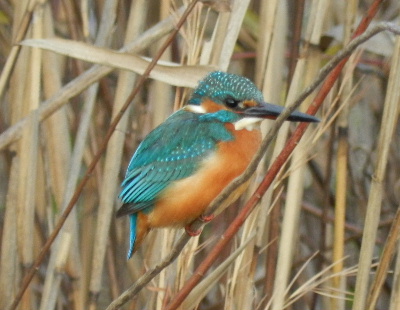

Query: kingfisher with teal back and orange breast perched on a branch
[{"left": 116, "top": 71, "right": 318, "bottom": 259}]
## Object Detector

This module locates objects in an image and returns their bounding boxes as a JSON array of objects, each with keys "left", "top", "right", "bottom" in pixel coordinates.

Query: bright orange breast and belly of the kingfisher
[{"left": 148, "top": 124, "right": 261, "bottom": 227}]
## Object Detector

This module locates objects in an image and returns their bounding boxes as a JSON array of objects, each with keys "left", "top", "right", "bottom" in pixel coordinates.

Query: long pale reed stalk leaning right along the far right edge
[{"left": 353, "top": 38, "right": 400, "bottom": 310}]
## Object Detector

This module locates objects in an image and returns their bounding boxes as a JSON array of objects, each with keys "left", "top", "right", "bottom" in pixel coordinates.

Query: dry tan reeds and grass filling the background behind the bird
[{"left": 0, "top": 0, "right": 400, "bottom": 310}]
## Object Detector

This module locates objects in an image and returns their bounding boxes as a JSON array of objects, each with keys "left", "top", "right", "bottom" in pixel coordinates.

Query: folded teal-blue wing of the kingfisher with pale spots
[{"left": 117, "top": 110, "right": 233, "bottom": 216}]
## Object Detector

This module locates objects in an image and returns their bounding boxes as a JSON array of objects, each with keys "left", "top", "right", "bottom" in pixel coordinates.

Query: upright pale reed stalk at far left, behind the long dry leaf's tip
[{"left": 17, "top": 3, "right": 43, "bottom": 306}]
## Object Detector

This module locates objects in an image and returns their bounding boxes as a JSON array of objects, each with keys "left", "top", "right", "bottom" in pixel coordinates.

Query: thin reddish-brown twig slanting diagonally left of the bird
[{"left": 9, "top": 0, "right": 199, "bottom": 310}]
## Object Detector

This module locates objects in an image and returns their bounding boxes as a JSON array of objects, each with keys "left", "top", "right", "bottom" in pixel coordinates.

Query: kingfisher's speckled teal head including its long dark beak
[{"left": 186, "top": 71, "right": 318, "bottom": 129}]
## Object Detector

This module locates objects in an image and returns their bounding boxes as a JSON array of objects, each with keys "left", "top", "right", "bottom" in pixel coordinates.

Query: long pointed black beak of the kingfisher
[{"left": 242, "top": 102, "right": 319, "bottom": 123}]
